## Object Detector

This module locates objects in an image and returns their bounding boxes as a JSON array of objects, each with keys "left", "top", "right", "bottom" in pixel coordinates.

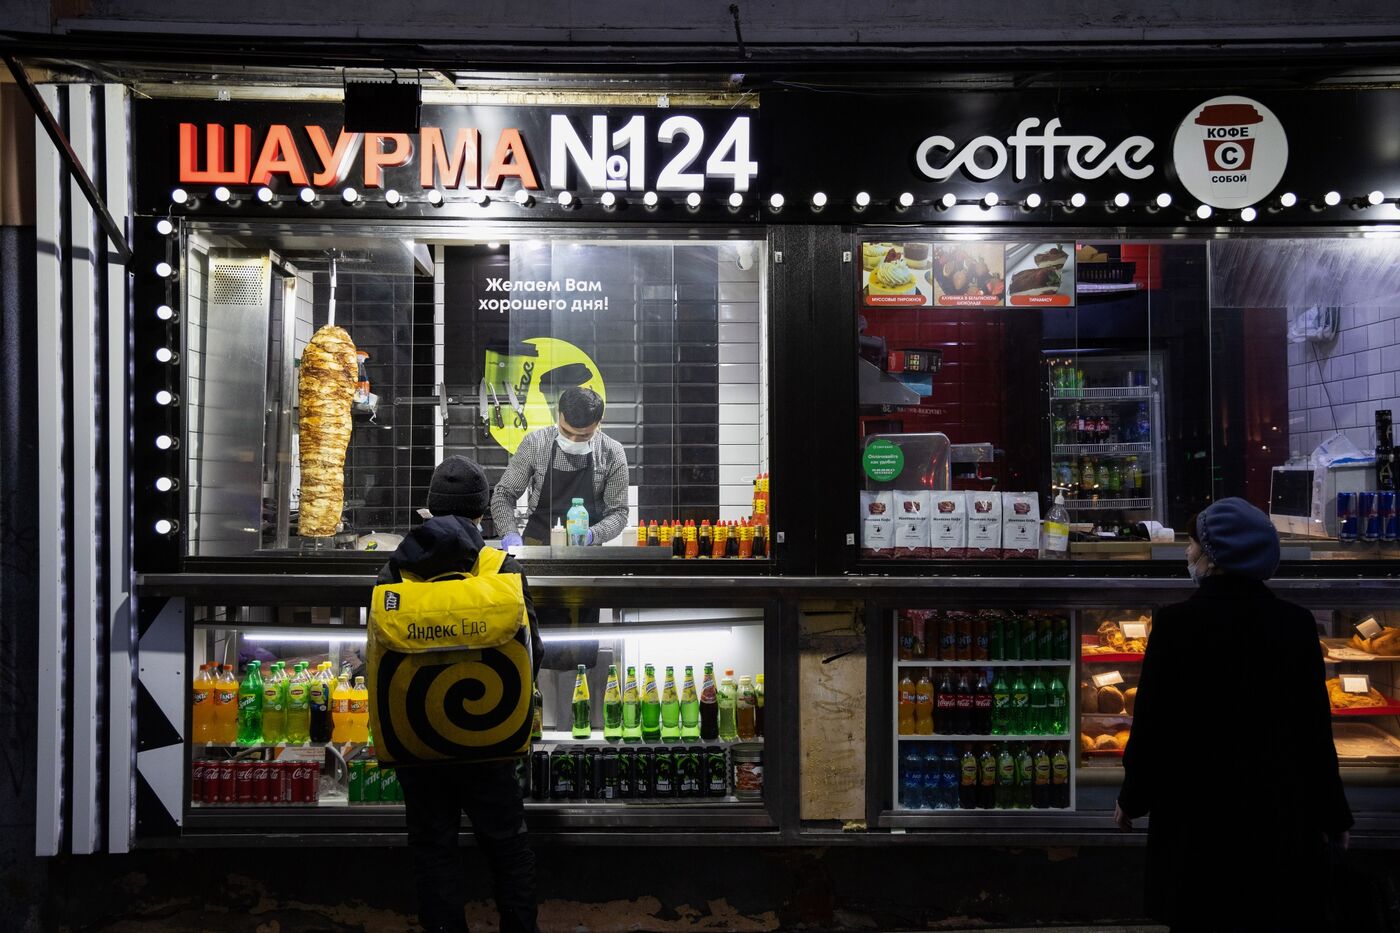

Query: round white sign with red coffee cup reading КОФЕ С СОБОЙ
[{"left": 1172, "top": 97, "right": 1288, "bottom": 210}]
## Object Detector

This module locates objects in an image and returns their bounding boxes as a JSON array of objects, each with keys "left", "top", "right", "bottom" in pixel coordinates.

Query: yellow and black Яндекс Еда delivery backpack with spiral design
[{"left": 365, "top": 548, "right": 535, "bottom": 765}]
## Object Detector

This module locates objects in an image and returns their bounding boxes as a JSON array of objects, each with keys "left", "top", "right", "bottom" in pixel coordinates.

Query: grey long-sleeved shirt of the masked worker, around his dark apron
[{"left": 491, "top": 424, "right": 629, "bottom": 544}]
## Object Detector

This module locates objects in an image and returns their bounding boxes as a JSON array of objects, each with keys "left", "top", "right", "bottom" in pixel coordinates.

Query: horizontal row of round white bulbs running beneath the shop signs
[{"left": 162, "top": 186, "right": 1400, "bottom": 219}]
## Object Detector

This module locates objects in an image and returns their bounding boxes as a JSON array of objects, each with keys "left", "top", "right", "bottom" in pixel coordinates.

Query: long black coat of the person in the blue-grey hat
[{"left": 1119, "top": 574, "right": 1352, "bottom": 932}]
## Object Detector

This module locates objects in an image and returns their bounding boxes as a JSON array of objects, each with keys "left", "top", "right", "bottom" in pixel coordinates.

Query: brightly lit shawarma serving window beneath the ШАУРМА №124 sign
[{"left": 175, "top": 224, "right": 770, "bottom": 560}]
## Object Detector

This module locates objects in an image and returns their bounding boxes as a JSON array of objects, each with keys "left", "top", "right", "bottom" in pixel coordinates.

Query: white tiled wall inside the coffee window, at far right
[{"left": 1288, "top": 305, "right": 1400, "bottom": 455}]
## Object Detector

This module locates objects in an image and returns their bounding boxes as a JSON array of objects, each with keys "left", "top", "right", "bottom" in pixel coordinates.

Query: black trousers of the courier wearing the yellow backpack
[{"left": 399, "top": 762, "right": 539, "bottom": 933}]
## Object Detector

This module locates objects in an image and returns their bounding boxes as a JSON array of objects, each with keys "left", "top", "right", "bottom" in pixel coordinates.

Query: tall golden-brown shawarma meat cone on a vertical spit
[{"left": 297, "top": 325, "right": 358, "bottom": 538}]
